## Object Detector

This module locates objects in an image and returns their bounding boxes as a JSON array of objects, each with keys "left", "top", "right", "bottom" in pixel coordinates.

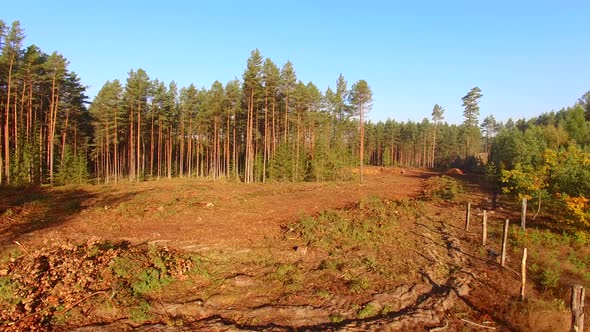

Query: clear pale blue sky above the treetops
[{"left": 0, "top": 0, "right": 590, "bottom": 123}]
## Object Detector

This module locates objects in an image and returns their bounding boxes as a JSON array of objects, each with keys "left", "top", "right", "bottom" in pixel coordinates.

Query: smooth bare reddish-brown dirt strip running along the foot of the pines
[{"left": 0, "top": 170, "right": 432, "bottom": 249}]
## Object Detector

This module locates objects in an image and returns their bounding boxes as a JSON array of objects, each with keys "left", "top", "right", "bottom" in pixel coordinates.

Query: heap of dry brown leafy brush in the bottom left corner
[{"left": 0, "top": 241, "right": 196, "bottom": 331}]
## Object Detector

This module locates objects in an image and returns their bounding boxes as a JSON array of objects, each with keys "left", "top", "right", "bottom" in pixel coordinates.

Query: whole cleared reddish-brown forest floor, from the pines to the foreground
[{"left": 0, "top": 168, "right": 590, "bottom": 331}]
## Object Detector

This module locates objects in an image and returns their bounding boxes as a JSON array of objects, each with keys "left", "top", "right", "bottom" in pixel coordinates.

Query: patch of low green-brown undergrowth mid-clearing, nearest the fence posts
[{"left": 286, "top": 197, "right": 420, "bottom": 294}]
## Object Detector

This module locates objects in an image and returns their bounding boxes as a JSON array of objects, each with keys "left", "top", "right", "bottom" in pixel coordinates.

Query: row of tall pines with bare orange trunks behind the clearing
[{"left": 0, "top": 21, "right": 590, "bottom": 185}]
